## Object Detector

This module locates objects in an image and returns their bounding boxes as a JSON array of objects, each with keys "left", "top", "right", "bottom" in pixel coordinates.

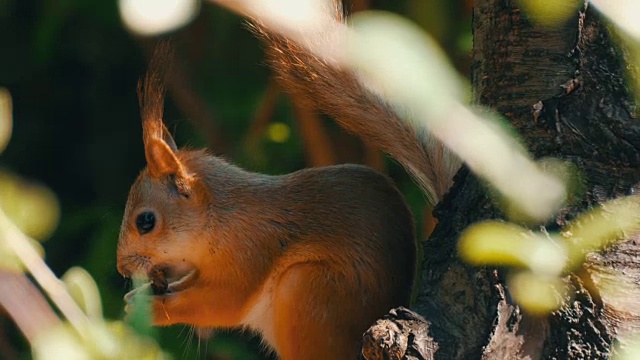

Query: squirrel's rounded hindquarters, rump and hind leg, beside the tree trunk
[{"left": 235, "top": 165, "right": 416, "bottom": 359}]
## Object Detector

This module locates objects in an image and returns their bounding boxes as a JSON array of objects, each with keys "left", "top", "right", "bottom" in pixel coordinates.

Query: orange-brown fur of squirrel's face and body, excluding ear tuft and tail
[{"left": 118, "top": 145, "right": 415, "bottom": 360}]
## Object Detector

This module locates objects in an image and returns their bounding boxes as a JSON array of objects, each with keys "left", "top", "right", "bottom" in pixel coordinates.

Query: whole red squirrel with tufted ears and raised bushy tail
[{"left": 117, "top": 1, "right": 453, "bottom": 360}]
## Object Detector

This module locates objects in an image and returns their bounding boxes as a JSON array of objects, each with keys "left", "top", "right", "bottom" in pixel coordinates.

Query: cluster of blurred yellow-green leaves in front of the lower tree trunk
[{"left": 459, "top": 195, "right": 640, "bottom": 313}]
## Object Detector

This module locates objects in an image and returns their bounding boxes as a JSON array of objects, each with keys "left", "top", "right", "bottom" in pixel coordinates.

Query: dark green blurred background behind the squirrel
[{"left": 0, "top": 0, "right": 471, "bottom": 359}]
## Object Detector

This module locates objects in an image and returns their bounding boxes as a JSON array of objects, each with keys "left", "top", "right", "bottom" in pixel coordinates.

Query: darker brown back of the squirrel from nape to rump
[{"left": 181, "top": 151, "right": 416, "bottom": 306}]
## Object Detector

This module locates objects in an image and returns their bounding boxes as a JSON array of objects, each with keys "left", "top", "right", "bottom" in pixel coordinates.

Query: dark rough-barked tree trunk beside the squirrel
[{"left": 363, "top": 0, "right": 640, "bottom": 359}]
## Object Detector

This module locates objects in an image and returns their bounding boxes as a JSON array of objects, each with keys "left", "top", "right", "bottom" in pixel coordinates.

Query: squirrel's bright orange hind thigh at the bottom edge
[{"left": 273, "top": 262, "right": 368, "bottom": 360}]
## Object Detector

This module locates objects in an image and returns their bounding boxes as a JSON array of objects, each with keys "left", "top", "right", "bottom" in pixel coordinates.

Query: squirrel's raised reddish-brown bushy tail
[{"left": 253, "top": 0, "right": 460, "bottom": 205}]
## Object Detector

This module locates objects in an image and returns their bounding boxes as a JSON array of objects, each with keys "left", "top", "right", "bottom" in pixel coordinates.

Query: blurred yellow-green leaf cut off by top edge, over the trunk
[{"left": 519, "top": 0, "right": 584, "bottom": 26}]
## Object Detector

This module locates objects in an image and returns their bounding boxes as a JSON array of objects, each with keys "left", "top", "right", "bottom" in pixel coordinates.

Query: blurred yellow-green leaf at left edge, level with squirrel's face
[{"left": 0, "top": 171, "right": 60, "bottom": 240}]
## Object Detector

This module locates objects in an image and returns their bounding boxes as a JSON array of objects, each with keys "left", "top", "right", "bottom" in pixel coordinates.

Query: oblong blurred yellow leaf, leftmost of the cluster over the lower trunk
[{"left": 458, "top": 221, "right": 566, "bottom": 275}]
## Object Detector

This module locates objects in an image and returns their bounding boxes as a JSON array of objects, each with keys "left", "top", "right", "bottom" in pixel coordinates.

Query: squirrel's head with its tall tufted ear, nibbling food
[{"left": 117, "top": 49, "right": 218, "bottom": 323}]
